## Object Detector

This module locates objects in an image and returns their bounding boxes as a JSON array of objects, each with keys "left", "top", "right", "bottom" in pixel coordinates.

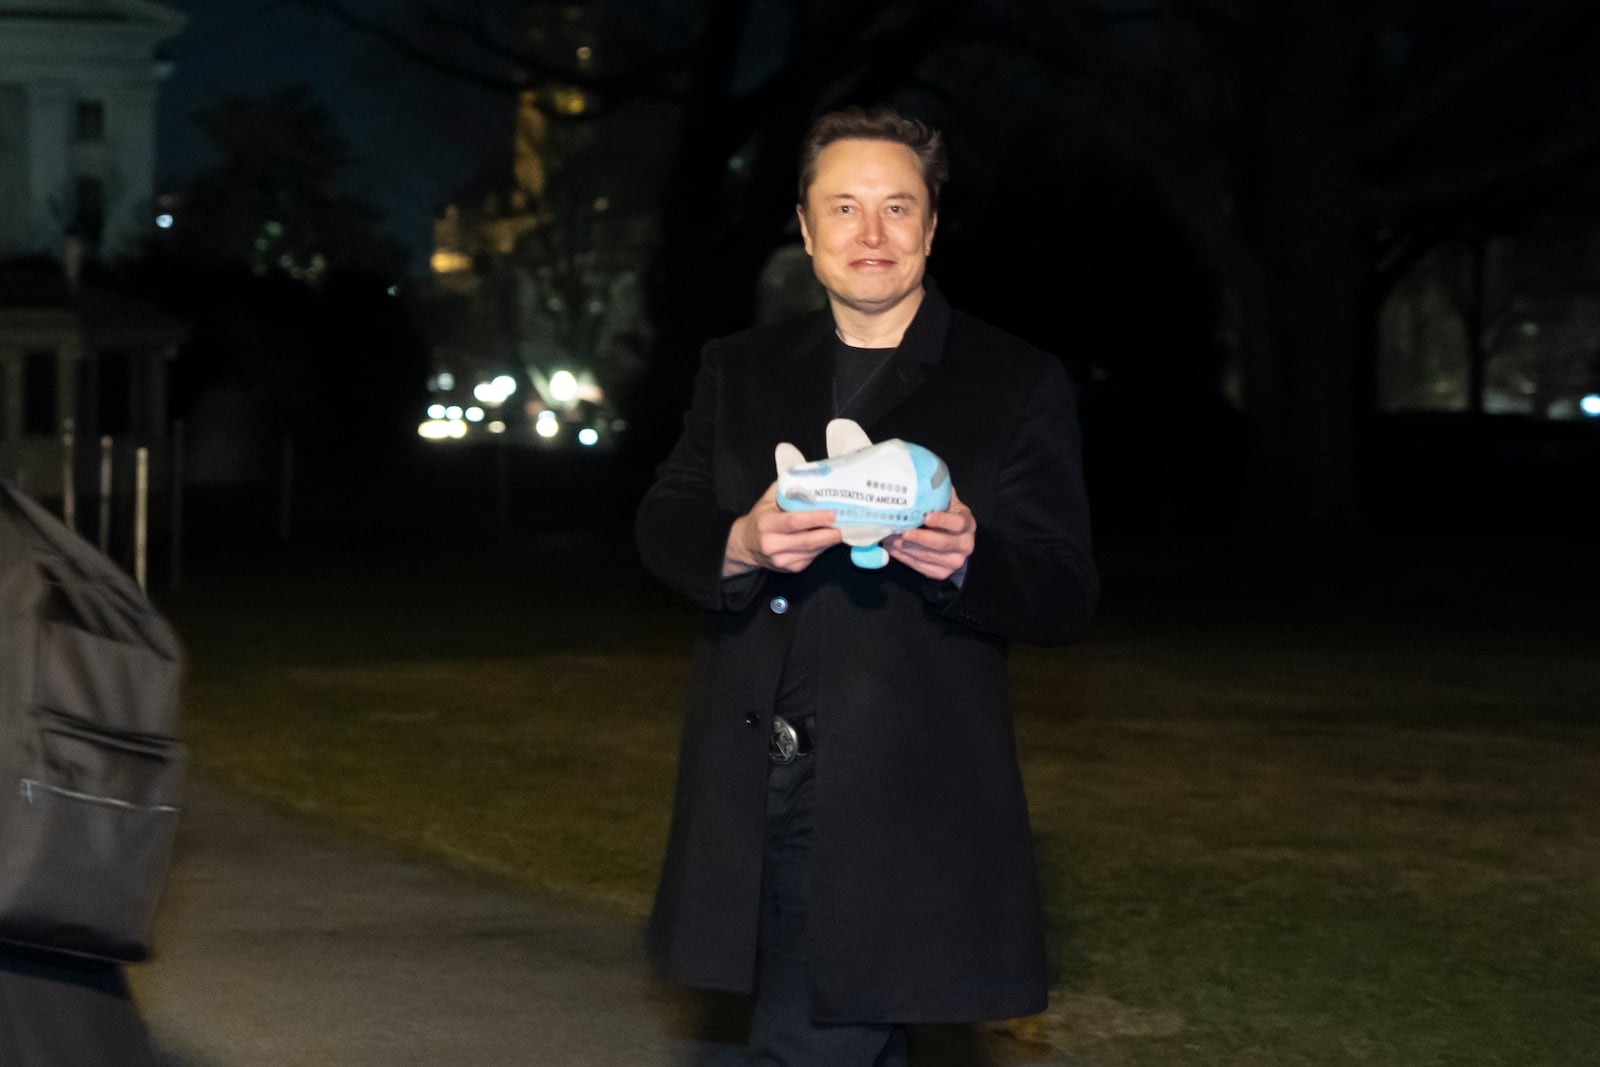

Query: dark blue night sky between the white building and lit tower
[{"left": 157, "top": 0, "right": 510, "bottom": 272}]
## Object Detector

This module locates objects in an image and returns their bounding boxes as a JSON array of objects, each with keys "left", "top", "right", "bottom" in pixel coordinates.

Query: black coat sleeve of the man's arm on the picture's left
[{"left": 634, "top": 341, "right": 766, "bottom": 611}]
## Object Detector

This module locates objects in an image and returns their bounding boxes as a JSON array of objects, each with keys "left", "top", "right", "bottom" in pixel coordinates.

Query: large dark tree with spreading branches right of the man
[{"left": 1037, "top": 0, "right": 1600, "bottom": 539}]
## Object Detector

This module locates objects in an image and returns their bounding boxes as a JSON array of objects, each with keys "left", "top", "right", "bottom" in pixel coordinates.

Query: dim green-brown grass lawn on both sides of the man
[{"left": 163, "top": 534, "right": 1600, "bottom": 1067}]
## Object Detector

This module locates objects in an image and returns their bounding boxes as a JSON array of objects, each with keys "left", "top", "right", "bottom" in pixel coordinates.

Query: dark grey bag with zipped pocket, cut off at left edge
[{"left": 0, "top": 482, "right": 187, "bottom": 963}]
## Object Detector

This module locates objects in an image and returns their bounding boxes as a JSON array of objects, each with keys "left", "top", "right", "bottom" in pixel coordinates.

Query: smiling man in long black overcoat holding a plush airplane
[{"left": 637, "top": 109, "right": 1096, "bottom": 1067}]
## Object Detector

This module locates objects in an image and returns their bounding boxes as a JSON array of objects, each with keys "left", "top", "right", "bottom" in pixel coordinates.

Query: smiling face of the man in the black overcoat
[{"left": 800, "top": 141, "right": 938, "bottom": 314}]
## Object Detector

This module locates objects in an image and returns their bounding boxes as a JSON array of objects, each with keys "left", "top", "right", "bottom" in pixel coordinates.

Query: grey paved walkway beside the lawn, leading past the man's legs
[{"left": 130, "top": 781, "right": 1067, "bottom": 1067}]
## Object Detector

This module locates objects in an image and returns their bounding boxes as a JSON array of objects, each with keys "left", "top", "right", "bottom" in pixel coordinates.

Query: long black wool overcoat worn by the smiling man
[{"left": 637, "top": 285, "right": 1098, "bottom": 1022}]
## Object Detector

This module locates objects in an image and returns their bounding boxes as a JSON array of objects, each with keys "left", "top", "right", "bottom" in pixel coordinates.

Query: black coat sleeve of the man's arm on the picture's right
[{"left": 930, "top": 358, "right": 1099, "bottom": 645}]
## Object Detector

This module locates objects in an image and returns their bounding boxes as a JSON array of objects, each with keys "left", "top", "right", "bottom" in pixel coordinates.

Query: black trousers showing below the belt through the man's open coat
[{"left": 750, "top": 742, "right": 906, "bottom": 1067}]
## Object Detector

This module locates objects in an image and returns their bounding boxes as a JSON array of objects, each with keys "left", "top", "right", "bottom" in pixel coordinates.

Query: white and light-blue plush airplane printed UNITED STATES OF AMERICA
[{"left": 773, "top": 419, "right": 950, "bottom": 569}]
